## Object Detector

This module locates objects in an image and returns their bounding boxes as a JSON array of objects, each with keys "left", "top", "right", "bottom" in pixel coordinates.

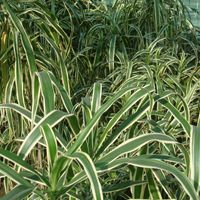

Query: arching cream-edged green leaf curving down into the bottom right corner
[{"left": 97, "top": 157, "right": 199, "bottom": 200}]
